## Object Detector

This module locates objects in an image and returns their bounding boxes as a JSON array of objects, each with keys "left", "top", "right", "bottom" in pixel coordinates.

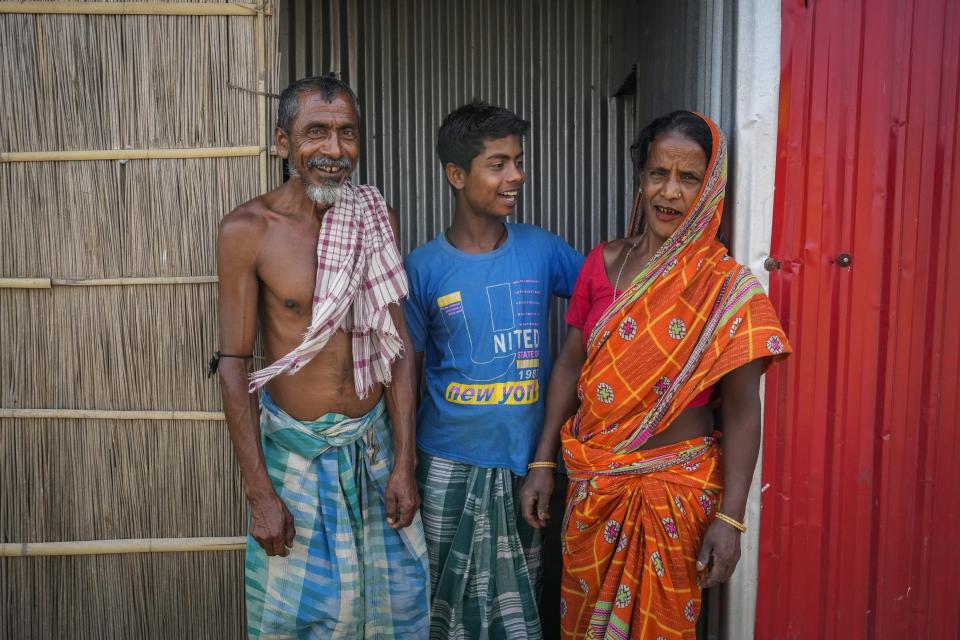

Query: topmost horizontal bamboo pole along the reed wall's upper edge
[{"left": 0, "top": 2, "right": 259, "bottom": 16}]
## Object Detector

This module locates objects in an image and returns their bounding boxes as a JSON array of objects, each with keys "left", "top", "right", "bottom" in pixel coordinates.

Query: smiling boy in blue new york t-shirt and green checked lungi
[{"left": 405, "top": 102, "right": 583, "bottom": 640}]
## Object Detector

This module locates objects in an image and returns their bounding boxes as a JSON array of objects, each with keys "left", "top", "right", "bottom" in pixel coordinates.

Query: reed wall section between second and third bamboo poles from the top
[{"left": 0, "top": 159, "right": 258, "bottom": 278}]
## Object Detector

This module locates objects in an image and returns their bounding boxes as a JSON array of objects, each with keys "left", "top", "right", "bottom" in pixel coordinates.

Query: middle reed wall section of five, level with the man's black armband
[{"left": 0, "top": 284, "right": 220, "bottom": 408}]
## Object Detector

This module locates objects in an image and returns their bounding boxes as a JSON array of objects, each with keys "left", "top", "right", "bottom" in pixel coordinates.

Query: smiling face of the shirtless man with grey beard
[{"left": 276, "top": 91, "right": 360, "bottom": 205}]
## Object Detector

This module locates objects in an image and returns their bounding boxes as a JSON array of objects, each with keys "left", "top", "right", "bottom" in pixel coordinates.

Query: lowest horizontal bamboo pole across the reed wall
[{"left": 0, "top": 536, "right": 247, "bottom": 558}]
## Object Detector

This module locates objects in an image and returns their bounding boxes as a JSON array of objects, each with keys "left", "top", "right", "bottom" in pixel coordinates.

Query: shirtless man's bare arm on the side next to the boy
[{"left": 384, "top": 208, "right": 420, "bottom": 529}]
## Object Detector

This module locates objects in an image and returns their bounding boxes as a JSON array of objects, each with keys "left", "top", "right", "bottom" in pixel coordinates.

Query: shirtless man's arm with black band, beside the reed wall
[{"left": 217, "top": 211, "right": 294, "bottom": 556}]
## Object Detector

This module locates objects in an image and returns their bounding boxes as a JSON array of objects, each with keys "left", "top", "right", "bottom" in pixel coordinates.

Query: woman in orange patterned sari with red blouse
[{"left": 521, "top": 111, "right": 790, "bottom": 640}]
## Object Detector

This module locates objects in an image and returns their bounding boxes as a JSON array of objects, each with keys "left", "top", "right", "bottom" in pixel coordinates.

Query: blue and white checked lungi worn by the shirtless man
[{"left": 246, "top": 392, "right": 430, "bottom": 640}]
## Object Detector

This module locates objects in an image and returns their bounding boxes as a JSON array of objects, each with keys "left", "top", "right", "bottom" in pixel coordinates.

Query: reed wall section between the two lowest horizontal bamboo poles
[{"left": 0, "top": 420, "right": 245, "bottom": 544}]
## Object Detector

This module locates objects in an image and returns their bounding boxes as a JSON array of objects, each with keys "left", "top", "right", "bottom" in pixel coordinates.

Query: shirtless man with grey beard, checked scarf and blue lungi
[{"left": 217, "top": 77, "right": 428, "bottom": 638}]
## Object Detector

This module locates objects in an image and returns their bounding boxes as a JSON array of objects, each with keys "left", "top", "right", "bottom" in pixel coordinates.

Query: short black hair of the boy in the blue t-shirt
[{"left": 437, "top": 100, "right": 530, "bottom": 173}]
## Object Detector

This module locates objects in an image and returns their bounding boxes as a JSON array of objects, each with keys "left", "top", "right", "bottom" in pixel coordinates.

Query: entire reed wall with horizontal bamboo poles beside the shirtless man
[{"left": 0, "top": 2, "right": 279, "bottom": 638}]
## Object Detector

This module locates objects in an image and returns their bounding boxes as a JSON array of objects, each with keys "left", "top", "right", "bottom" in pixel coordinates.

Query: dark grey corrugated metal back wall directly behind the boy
[{"left": 280, "top": 0, "right": 633, "bottom": 264}]
